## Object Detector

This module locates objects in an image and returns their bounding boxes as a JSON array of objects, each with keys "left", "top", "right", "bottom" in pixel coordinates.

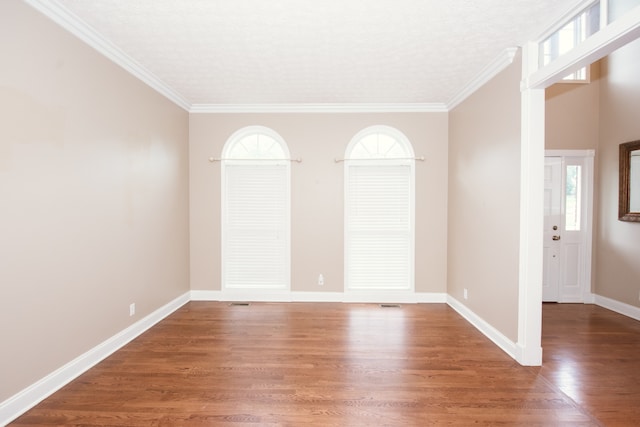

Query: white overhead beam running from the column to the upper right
[{"left": 523, "top": 6, "right": 640, "bottom": 89}]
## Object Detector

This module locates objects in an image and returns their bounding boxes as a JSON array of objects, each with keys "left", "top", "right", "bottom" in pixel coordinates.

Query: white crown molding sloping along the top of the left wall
[{"left": 24, "top": 0, "right": 191, "bottom": 111}]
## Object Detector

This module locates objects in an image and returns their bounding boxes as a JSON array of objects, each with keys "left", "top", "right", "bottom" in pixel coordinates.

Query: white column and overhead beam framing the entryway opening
[{"left": 516, "top": 6, "right": 640, "bottom": 366}]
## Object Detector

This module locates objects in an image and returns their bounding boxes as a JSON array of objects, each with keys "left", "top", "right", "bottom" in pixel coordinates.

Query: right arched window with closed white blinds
[{"left": 345, "top": 126, "right": 415, "bottom": 291}]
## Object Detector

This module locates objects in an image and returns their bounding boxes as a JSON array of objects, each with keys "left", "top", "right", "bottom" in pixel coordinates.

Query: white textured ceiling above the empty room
[{"left": 50, "top": 0, "right": 576, "bottom": 105}]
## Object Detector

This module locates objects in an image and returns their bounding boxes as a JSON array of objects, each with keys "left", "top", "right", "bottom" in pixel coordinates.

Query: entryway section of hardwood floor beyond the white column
[{"left": 540, "top": 304, "right": 640, "bottom": 426}]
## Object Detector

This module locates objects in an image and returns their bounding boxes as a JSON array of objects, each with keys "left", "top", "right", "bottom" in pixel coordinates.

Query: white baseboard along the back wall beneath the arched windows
[{"left": 191, "top": 290, "right": 447, "bottom": 304}]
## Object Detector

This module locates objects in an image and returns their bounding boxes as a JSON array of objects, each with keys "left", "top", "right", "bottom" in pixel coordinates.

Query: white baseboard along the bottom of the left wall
[{"left": 0, "top": 292, "right": 189, "bottom": 425}]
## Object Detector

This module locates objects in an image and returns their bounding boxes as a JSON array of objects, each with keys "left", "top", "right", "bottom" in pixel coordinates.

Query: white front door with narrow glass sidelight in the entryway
[{"left": 542, "top": 151, "right": 593, "bottom": 302}]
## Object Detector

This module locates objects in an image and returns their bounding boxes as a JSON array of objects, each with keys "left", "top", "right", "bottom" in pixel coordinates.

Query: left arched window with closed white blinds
[{"left": 221, "top": 126, "right": 290, "bottom": 291}]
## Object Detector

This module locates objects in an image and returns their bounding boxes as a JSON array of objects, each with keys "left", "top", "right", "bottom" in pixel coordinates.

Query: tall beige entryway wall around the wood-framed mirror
[{"left": 594, "top": 40, "right": 640, "bottom": 307}]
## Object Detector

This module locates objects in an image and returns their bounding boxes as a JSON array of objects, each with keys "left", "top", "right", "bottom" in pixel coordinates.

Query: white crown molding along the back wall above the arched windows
[{"left": 189, "top": 103, "right": 448, "bottom": 113}]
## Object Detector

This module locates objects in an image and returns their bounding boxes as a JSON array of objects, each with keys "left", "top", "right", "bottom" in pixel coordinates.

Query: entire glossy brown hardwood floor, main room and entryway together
[{"left": 12, "top": 302, "right": 640, "bottom": 426}]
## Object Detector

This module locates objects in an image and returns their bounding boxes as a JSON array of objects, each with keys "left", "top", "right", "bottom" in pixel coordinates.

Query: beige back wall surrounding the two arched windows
[{"left": 189, "top": 113, "right": 447, "bottom": 293}]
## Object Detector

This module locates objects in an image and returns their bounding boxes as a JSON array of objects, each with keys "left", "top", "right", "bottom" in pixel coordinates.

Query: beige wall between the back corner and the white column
[{"left": 448, "top": 51, "right": 521, "bottom": 342}]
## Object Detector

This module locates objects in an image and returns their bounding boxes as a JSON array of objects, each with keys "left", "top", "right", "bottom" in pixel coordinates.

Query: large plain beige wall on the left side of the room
[{"left": 0, "top": 1, "right": 189, "bottom": 402}]
